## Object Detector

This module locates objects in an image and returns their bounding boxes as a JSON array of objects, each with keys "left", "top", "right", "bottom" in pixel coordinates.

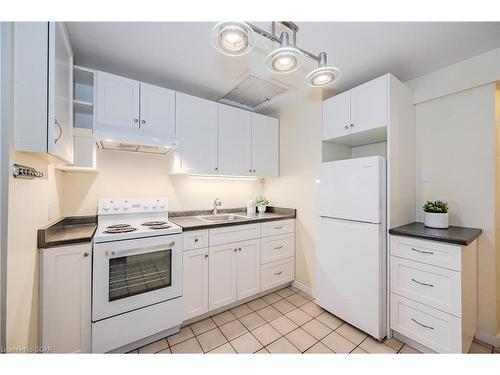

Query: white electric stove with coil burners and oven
[{"left": 92, "top": 198, "right": 182, "bottom": 352}]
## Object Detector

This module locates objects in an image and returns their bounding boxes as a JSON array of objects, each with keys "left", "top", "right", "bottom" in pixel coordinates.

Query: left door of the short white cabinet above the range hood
[{"left": 95, "top": 71, "right": 139, "bottom": 134}]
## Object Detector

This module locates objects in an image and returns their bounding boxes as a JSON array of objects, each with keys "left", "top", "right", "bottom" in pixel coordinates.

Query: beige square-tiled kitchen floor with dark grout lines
[{"left": 131, "top": 287, "right": 498, "bottom": 354}]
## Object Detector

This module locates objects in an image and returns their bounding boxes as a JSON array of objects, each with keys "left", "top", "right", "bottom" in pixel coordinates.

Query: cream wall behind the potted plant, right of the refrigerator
[{"left": 416, "top": 83, "right": 497, "bottom": 334}]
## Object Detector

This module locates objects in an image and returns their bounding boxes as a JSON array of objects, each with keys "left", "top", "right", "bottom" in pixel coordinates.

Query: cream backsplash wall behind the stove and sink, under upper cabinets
[{"left": 64, "top": 150, "right": 263, "bottom": 216}]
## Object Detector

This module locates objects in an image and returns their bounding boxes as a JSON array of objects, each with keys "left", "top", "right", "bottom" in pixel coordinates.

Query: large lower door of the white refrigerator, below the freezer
[{"left": 316, "top": 214, "right": 386, "bottom": 339}]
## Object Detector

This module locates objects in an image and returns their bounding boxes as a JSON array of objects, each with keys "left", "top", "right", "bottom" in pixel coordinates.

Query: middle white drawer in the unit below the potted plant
[{"left": 391, "top": 256, "right": 462, "bottom": 317}]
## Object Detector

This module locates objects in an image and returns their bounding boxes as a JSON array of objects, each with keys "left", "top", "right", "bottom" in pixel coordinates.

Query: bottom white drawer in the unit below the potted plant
[{"left": 391, "top": 293, "right": 462, "bottom": 353}]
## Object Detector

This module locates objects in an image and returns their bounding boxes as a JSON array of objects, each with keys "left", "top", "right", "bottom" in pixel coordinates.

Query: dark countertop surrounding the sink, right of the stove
[{"left": 168, "top": 207, "right": 296, "bottom": 231}]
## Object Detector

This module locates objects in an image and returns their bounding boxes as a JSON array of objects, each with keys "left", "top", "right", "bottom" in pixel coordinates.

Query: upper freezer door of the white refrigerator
[{"left": 316, "top": 156, "right": 386, "bottom": 223}]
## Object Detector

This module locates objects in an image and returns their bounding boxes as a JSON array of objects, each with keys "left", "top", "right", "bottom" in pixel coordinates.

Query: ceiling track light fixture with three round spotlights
[{"left": 212, "top": 21, "right": 340, "bottom": 87}]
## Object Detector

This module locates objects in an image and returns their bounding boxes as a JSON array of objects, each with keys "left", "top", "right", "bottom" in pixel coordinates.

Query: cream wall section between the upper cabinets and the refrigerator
[{"left": 265, "top": 91, "right": 322, "bottom": 288}]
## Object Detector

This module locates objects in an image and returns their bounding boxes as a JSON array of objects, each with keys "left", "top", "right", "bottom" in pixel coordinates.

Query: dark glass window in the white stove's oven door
[{"left": 109, "top": 250, "right": 172, "bottom": 302}]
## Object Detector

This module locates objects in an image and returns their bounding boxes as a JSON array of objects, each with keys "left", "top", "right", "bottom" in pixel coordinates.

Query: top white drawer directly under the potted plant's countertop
[{"left": 390, "top": 236, "right": 461, "bottom": 271}]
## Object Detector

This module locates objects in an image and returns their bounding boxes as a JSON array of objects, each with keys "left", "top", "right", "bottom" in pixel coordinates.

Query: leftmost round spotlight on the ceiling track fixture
[{"left": 212, "top": 22, "right": 255, "bottom": 56}]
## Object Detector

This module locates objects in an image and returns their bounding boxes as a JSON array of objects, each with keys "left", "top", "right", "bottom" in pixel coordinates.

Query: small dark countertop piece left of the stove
[{"left": 38, "top": 216, "right": 97, "bottom": 249}]
